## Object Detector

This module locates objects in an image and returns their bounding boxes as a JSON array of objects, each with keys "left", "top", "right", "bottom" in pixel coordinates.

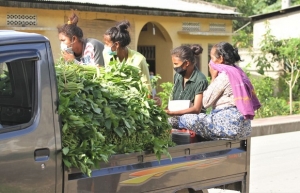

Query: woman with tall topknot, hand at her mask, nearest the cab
[{"left": 57, "top": 13, "right": 104, "bottom": 66}]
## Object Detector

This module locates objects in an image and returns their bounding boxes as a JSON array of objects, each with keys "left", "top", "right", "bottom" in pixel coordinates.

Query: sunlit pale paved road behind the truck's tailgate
[{"left": 209, "top": 132, "right": 300, "bottom": 193}]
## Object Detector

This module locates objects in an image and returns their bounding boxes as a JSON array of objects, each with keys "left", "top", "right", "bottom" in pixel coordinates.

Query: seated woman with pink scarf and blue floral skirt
[{"left": 179, "top": 42, "right": 260, "bottom": 140}]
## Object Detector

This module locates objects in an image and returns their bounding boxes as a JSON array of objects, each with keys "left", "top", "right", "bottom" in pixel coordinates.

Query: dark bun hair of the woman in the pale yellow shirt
[{"left": 104, "top": 20, "right": 131, "bottom": 48}]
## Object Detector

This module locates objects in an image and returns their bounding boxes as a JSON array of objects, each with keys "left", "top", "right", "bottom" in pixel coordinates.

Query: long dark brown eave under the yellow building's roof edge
[{"left": 0, "top": 0, "right": 249, "bottom": 21}]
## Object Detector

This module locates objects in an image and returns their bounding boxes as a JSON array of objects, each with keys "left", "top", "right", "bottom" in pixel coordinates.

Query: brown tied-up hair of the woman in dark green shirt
[{"left": 171, "top": 44, "right": 203, "bottom": 64}]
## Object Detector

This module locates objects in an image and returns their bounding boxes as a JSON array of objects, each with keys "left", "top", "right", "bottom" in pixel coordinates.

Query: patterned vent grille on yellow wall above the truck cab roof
[{"left": 6, "top": 14, "right": 37, "bottom": 27}]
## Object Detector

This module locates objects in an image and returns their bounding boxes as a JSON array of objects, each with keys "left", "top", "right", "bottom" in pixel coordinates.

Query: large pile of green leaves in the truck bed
[{"left": 55, "top": 61, "right": 172, "bottom": 175}]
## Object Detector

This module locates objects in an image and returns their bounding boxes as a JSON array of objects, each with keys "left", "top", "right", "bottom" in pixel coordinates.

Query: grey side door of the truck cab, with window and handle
[{"left": 0, "top": 42, "right": 62, "bottom": 193}]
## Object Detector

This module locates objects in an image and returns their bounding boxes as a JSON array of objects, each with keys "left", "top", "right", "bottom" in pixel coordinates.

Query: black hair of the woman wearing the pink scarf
[{"left": 213, "top": 42, "right": 241, "bottom": 65}]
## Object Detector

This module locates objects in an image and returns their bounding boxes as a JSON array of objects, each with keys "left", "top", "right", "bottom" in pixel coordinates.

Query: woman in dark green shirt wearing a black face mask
[{"left": 166, "top": 44, "right": 208, "bottom": 129}]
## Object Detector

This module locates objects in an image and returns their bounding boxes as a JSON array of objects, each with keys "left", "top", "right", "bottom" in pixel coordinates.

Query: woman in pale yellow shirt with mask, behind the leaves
[{"left": 103, "top": 21, "right": 152, "bottom": 92}]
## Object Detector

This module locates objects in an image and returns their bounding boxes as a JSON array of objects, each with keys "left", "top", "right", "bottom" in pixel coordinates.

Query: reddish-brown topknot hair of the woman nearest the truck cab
[{"left": 57, "top": 13, "right": 83, "bottom": 41}]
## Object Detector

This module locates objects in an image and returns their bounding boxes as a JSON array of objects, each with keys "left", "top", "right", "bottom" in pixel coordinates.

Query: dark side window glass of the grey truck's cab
[{"left": 0, "top": 59, "right": 36, "bottom": 133}]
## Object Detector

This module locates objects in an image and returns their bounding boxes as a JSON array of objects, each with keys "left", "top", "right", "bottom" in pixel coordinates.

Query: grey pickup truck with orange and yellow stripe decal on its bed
[{"left": 0, "top": 30, "right": 250, "bottom": 193}]
